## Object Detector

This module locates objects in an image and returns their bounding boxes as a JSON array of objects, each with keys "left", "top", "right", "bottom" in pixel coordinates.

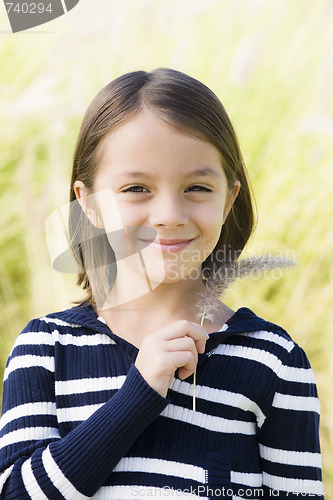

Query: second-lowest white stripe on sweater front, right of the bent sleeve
[{"left": 113, "top": 457, "right": 205, "bottom": 483}]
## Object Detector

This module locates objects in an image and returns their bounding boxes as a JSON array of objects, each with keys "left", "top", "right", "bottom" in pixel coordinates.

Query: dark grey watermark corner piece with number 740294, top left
[{"left": 3, "top": 0, "right": 80, "bottom": 33}]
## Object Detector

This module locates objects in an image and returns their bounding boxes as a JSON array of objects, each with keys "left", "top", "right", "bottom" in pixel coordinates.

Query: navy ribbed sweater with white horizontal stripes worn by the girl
[{"left": 0, "top": 306, "right": 323, "bottom": 500}]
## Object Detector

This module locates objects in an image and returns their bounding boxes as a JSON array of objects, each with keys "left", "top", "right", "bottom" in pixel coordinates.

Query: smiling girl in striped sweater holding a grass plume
[{"left": 0, "top": 69, "right": 323, "bottom": 500}]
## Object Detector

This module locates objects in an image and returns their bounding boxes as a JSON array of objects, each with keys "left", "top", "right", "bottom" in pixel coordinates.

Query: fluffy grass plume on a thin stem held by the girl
[{"left": 193, "top": 255, "right": 295, "bottom": 411}]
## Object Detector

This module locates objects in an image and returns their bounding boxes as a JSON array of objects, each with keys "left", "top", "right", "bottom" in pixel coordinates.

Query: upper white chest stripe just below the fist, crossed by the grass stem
[{"left": 172, "top": 379, "right": 266, "bottom": 428}]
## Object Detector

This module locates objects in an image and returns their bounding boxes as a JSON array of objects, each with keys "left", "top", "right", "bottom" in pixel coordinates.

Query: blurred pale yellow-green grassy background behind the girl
[{"left": 0, "top": 0, "right": 333, "bottom": 488}]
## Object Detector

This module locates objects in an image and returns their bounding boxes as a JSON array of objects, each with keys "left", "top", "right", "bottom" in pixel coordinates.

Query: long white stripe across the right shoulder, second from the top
[{"left": 213, "top": 344, "right": 315, "bottom": 384}]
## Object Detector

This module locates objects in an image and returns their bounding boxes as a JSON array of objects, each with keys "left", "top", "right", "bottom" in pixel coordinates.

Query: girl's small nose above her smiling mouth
[{"left": 150, "top": 193, "right": 188, "bottom": 229}]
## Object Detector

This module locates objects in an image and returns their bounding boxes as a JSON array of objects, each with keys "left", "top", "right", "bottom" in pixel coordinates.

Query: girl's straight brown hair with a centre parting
[{"left": 70, "top": 68, "right": 255, "bottom": 303}]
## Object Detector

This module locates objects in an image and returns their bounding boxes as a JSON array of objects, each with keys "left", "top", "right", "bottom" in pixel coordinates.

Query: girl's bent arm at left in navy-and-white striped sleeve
[{"left": 0, "top": 321, "right": 167, "bottom": 500}]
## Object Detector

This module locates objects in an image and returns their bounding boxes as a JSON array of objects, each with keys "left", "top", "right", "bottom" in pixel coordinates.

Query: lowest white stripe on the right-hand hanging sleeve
[{"left": 263, "top": 472, "right": 324, "bottom": 495}]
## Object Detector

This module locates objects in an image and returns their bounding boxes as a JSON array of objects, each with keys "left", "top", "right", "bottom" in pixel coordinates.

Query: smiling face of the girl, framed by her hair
[{"left": 76, "top": 111, "right": 239, "bottom": 288}]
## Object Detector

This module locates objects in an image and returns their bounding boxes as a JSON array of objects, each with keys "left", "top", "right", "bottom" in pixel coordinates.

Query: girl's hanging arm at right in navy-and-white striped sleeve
[{"left": 258, "top": 345, "right": 324, "bottom": 500}]
